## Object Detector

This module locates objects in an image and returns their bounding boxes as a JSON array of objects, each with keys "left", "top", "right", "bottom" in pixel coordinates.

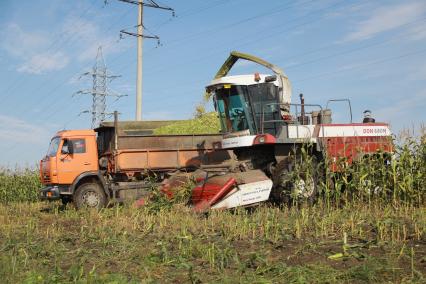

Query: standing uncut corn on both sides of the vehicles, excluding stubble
[{"left": 0, "top": 134, "right": 426, "bottom": 205}]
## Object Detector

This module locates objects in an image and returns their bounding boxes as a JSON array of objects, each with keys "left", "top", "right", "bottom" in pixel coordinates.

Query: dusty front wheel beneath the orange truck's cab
[{"left": 74, "top": 183, "right": 107, "bottom": 209}]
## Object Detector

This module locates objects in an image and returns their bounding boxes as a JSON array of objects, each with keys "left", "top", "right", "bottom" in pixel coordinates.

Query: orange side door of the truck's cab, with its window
[{"left": 57, "top": 137, "right": 98, "bottom": 184}]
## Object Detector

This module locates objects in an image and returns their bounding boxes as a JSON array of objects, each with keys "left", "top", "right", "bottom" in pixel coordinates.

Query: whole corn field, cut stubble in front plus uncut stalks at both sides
[{"left": 0, "top": 134, "right": 426, "bottom": 283}]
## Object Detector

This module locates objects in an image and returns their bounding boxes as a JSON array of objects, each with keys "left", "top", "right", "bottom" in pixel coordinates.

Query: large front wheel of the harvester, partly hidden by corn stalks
[{"left": 271, "top": 157, "right": 318, "bottom": 205}]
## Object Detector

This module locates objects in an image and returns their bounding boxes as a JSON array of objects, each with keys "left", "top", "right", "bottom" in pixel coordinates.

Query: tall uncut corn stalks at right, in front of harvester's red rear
[{"left": 323, "top": 135, "right": 426, "bottom": 205}]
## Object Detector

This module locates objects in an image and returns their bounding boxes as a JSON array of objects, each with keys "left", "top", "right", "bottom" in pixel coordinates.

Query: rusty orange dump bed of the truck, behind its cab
[{"left": 96, "top": 123, "right": 231, "bottom": 172}]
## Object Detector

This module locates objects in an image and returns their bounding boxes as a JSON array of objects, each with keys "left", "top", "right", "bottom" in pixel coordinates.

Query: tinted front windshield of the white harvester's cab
[{"left": 215, "top": 85, "right": 255, "bottom": 133}]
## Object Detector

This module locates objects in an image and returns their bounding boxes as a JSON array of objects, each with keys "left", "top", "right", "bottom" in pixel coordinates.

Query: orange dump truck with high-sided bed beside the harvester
[{"left": 40, "top": 115, "right": 229, "bottom": 208}]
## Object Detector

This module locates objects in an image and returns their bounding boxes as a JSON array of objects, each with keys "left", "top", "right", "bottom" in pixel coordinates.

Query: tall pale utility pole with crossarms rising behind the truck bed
[{"left": 118, "top": 0, "right": 174, "bottom": 120}]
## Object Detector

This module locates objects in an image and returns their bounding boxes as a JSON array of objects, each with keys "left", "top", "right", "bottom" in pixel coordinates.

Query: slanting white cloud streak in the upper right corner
[{"left": 343, "top": 2, "right": 426, "bottom": 42}]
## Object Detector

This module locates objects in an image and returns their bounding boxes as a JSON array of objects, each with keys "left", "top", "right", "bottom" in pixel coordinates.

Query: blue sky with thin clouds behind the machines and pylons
[{"left": 0, "top": 0, "right": 426, "bottom": 167}]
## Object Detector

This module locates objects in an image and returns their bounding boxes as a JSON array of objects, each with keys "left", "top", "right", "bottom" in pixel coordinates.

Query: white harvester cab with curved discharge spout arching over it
[{"left": 206, "top": 52, "right": 291, "bottom": 140}]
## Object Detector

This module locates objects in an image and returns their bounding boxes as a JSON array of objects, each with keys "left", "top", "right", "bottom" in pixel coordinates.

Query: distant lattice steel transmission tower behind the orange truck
[{"left": 75, "top": 46, "right": 126, "bottom": 128}]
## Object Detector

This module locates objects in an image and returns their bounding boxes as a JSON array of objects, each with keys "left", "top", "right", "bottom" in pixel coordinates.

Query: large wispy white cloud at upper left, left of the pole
[{"left": 0, "top": 12, "right": 130, "bottom": 74}]
